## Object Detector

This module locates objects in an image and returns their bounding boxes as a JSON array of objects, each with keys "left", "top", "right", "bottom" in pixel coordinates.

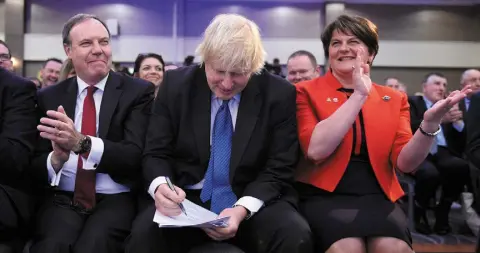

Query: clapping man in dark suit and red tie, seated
[{"left": 30, "top": 14, "right": 154, "bottom": 253}]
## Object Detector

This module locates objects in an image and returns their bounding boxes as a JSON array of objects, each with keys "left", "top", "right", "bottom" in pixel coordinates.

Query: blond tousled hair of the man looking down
[{"left": 196, "top": 14, "right": 266, "bottom": 74}]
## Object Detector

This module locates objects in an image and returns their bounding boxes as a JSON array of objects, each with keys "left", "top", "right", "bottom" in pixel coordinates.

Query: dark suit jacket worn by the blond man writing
[{"left": 143, "top": 65, "right": 299, "bottom": 205}]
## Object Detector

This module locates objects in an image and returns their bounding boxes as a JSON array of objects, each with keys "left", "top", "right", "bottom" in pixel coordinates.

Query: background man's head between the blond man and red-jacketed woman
[{"left": 287, "top": 50, "right": 320, "bottom": 84}]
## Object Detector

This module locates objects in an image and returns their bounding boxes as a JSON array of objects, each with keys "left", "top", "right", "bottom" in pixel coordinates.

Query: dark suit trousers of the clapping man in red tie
[{"left": 30, "top": 192, "right": 135, "bottom": 253}]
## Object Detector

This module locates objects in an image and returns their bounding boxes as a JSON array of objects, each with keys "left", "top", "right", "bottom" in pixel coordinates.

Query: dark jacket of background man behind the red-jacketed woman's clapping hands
[{"left": 408, "top": 96, "right": 466, "bottom": 158}]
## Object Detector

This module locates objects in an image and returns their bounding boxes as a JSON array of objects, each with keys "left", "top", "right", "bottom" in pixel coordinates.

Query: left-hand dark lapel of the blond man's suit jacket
[{"left": 192, "top": 67, "right": 212, "bottom": 164}]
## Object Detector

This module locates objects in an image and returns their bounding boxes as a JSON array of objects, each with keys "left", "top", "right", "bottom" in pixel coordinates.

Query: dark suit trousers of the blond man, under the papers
[{"left": 126, "top": 191, "right": 313, "bottom": 253}]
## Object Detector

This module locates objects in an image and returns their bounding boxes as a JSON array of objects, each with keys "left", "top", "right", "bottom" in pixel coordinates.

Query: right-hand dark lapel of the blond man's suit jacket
[{"left": 230, "top": 74, "right": 260, "bottom": 181}]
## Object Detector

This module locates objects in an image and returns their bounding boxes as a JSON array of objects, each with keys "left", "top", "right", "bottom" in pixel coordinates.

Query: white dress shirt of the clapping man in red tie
[{"left": 47, "top": 75, "right": 130, "bottom": 194}]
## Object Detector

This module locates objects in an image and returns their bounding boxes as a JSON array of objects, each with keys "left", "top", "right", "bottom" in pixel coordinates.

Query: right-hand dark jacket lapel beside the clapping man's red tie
[{"left": 98, "top": 71, "right": 122, "bottom": 138}]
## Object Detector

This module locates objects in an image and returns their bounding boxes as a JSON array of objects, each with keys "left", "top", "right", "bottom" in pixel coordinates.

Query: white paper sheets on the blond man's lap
[{"left": 153, "top": 199, "right": 229, "bottom": 228}]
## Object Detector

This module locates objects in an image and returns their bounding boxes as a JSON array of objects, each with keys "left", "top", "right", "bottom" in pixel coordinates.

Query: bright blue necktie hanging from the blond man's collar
[{"left": 200, "top": 100, "right": 237, "bottom": 214}]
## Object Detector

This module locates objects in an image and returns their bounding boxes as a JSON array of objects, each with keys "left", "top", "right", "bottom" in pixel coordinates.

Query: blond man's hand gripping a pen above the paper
[{"left": 154, "top": 177, "right": 187, "bottom": 216}]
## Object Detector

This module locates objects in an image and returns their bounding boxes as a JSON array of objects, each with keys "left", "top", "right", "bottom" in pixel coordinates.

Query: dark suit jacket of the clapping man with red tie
[{"left": 31, "top": 71, "right": 154, "bottom": 191}]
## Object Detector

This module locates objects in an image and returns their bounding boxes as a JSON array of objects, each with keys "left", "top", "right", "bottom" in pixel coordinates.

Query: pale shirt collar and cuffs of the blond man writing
[{"left": 148, "top": 94, "right": 264, "bottom": 215}]
